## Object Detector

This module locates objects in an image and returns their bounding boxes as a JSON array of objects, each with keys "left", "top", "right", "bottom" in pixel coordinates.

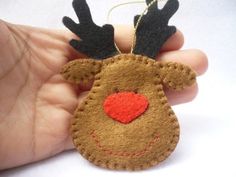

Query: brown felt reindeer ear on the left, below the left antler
[{"left": 61, "top": 59, "right": 102, "bottom": 84}]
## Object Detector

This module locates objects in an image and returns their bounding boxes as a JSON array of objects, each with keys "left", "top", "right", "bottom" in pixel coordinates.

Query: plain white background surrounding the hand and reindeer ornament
[{"left": 0, "top": 0, "right": 236, "bottom": 177}]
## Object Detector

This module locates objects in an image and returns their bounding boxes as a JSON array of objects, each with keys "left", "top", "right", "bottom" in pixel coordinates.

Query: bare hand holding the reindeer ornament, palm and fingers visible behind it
[{"left": 0, "top": 21, "right": 207, "bottom": 169}]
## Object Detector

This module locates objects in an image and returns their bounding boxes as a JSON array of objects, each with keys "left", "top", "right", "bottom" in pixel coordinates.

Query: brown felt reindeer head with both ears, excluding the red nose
[{"left": 61, "top": 54, "right": 196, "bottom": 170}]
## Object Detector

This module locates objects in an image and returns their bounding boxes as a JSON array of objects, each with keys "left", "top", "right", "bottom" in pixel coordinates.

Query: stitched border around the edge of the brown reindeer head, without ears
[{"left": 68, "top": 54, "right": 190, "bottom": 170}]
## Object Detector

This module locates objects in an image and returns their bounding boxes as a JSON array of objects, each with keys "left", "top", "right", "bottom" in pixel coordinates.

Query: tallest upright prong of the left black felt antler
[{"left": 72, "top": 0, "right": 93, "bottom": 24}]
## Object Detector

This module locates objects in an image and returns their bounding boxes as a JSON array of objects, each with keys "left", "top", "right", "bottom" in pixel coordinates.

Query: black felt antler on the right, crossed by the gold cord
[{"left": 133, "top": 0, "right": 179, "bottom": 59}]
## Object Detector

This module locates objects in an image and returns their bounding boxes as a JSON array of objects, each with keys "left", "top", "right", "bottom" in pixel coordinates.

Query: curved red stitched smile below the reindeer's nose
[{"left": 90, "top": 130, "right": 160, "bottom": 158}]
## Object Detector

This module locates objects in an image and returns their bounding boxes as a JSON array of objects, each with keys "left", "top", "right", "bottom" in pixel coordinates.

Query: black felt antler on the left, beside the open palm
[{"left": 63, "top": 0, "right": 118, "bottom": 59}]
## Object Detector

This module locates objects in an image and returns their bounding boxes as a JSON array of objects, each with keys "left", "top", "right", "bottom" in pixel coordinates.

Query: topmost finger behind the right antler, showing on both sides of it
[{"left": 114, "top": 25, "right": 184, "bottom": 52}]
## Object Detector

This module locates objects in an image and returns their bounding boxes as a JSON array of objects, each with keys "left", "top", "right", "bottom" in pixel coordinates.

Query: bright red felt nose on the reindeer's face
[{"left": 103, "top": 92, "right": 148, "bottom": 124}]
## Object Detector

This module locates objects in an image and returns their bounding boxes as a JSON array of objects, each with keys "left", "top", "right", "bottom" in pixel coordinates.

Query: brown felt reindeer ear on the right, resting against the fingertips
[{"left": 159, "top": 62, "right": 196, "bottom": 90}]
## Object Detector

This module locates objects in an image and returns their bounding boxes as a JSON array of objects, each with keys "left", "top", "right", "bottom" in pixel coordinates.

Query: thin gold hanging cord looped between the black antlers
[{"left": 107, "top": 0, "right": 164, "bottom": 53}]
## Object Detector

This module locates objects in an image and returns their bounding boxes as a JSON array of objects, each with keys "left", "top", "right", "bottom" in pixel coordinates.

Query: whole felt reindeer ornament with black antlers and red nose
[{"left": 61, "top": 0, "right": 196, "bottom": 170}]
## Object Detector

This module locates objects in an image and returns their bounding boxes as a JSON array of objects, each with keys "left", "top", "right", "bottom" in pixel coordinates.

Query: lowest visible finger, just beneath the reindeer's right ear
[{"left": 165, "top": 84, "right": 198, "bottom": 106}]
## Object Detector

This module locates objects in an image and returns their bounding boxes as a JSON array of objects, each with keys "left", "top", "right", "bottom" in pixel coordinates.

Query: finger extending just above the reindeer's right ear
[{"left": 157, "top": 49, "right": 208, "bottom": 75}]
